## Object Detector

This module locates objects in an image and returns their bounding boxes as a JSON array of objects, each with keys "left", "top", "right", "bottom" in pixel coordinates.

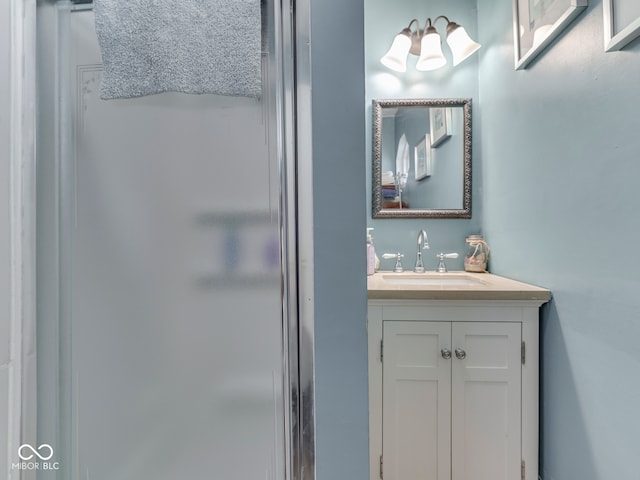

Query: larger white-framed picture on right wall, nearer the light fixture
[{"left": 513, "top": 0, "right": 588, "bottom": 70}]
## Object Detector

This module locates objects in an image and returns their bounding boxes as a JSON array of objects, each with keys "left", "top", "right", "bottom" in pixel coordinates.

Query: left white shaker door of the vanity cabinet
[{"left": 382, "top": 321, "right": 451, "bottom": 480}]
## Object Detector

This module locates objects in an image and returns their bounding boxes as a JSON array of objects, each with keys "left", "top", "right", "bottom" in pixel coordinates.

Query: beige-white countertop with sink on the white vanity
[{"left": 367, "top": 271, "right": 551, "bottom": 303}]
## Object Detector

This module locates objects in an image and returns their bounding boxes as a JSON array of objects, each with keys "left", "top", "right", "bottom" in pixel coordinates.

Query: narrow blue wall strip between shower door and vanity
[{"left": 312, "top": 0, "right": 369, "bottom": 480}]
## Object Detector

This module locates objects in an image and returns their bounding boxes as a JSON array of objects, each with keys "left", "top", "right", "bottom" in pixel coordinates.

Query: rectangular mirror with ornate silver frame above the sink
[{"left": 371, "top": 98, "right": 471, "bottom": 218}]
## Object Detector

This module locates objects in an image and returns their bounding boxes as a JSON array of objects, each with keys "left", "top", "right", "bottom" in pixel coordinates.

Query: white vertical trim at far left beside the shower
[{"left": 7, "top": 0, "right": 36, "bottom": 480}]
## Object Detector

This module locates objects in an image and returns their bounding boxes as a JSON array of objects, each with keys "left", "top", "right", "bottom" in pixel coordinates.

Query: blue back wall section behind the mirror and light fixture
[{"left": 364, "top": 0, "right": 482, "bottom": 270}]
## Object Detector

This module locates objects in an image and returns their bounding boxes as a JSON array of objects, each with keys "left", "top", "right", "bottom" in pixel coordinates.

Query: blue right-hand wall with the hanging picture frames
[{"left": 474, "top": 0, "right": 640, "bottom": 480}]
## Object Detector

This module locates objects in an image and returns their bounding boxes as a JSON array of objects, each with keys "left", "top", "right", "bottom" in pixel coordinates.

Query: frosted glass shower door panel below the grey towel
[{"left": 67, "top": 11, "right": 284, "bottom": 480}]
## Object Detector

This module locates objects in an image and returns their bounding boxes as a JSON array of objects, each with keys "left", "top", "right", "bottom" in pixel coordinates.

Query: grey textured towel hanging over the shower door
[{"left": 94, "top": 0, "right": 262, "bottom": 99}]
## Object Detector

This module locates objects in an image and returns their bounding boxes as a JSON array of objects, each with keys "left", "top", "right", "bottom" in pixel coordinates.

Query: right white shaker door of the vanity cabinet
[{"left": 451, "top": 322, "right": 522, "bottom": 480}]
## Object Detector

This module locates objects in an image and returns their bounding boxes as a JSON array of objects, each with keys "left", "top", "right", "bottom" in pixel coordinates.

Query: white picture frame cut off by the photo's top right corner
[{"left": 603, "top": 0, "right": 640, "bottom": 52}]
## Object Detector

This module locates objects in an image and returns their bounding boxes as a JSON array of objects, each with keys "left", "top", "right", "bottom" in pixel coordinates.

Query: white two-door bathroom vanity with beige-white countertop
[{"left": 367, "top": 272, "right": 551, "bottom": 480}]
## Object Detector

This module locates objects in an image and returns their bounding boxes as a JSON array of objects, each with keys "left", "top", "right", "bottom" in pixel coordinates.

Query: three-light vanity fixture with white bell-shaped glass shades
[{"left": 380, "top": 15, "right": 480, "bottom": 72}]
